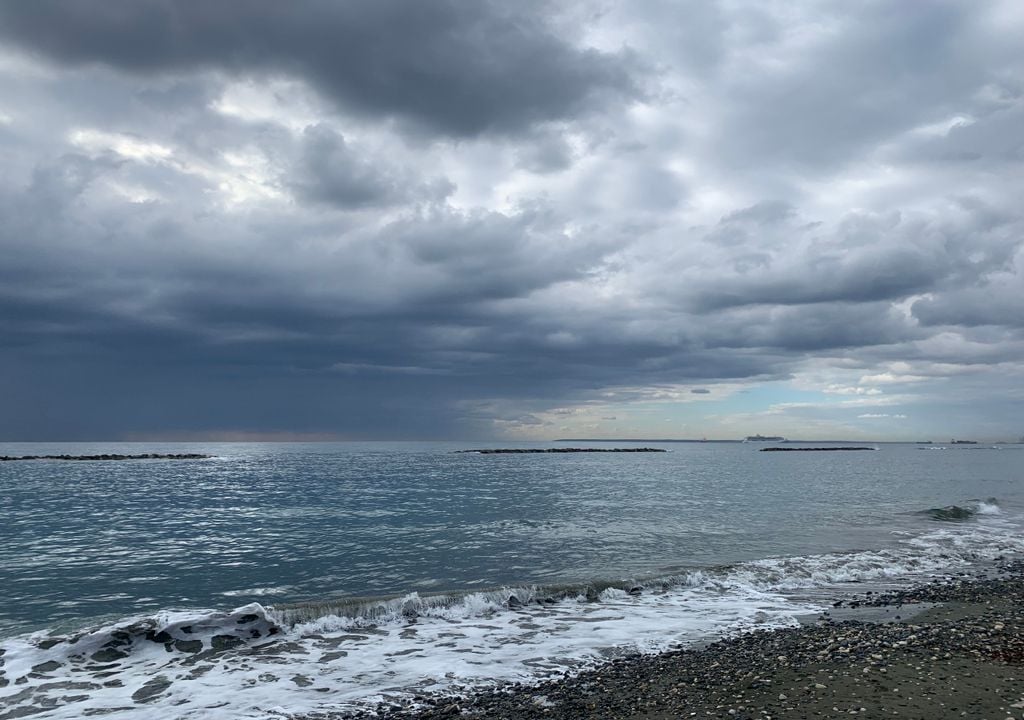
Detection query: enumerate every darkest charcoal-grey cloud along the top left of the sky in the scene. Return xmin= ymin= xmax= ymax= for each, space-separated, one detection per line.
xmin=0 ymin=0 xmax=638 ymax=135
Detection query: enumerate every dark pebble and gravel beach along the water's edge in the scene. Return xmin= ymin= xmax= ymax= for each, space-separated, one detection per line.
xmin=305 ymin=563 xmax=1024 ymax=720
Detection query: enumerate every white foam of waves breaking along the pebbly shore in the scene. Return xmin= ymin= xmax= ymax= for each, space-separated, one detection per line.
xmin=6 ymin=505 xmax=1024 ymax=720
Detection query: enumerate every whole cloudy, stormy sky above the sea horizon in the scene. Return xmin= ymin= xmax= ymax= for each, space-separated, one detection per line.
xmin=0 ymin=0 xmax=1024 ymax=441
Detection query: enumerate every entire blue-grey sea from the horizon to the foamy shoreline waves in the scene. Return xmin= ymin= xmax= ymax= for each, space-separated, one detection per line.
xmin=0 ymin=442 xmax=1024 ymax=719
